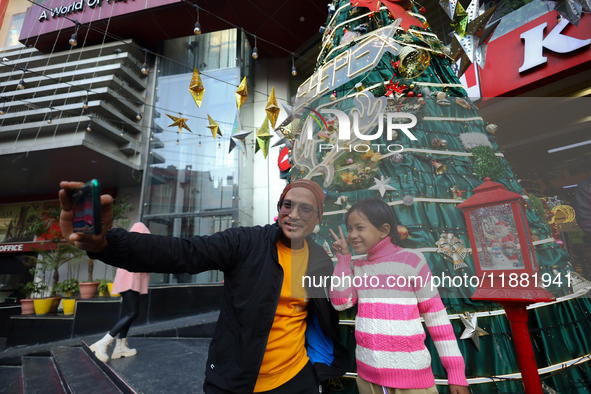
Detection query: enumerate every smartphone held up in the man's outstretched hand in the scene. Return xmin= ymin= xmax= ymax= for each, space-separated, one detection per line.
xmin=72 ymin=179 xmax=102 ymax=235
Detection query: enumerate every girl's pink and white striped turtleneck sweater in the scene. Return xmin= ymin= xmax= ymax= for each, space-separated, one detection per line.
xmin=330 ymin=237 xmax=468 ymax=389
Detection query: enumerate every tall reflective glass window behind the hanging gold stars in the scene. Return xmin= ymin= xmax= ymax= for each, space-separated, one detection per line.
xmin=142 ymin=29 xmax=254 ymax=283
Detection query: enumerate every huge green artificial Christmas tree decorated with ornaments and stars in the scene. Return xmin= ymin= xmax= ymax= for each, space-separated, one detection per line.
xmin=280 ymin=0 xmax=591 ymax=393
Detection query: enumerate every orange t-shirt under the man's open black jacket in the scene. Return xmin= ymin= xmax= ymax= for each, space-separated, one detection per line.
xmin=254 ymin=241 xmax=308 ymax=393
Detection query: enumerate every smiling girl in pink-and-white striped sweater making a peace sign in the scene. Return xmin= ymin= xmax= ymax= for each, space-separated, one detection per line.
xmin=330 ymin=199 xmax=469 ymax=394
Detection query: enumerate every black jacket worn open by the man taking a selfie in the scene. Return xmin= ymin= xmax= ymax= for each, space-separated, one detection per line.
xmin=88 ymin=223 xmax=349 ymax=394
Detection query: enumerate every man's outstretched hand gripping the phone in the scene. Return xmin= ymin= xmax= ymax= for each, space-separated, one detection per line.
xmin=59 ymin=181 xmax=113 ymax=253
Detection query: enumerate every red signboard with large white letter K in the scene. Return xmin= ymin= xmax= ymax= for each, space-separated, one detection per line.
xmin=464 ymin=11 xmax=591 ymax=97
